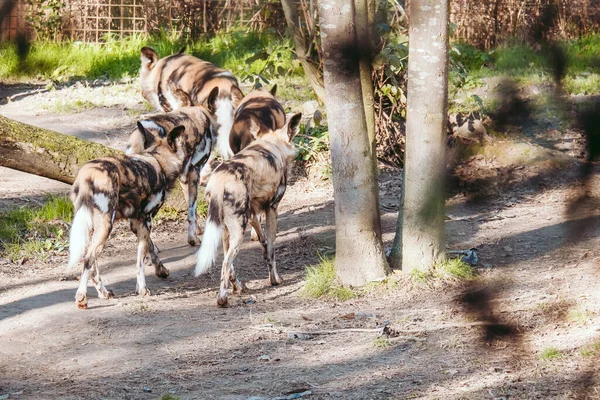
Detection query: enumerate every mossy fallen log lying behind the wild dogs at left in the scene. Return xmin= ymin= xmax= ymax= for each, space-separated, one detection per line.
xmin=0 ymin=115 xmax=187 ymax=210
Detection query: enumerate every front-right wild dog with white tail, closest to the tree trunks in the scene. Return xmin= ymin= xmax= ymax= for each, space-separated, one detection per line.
xmin=194 ymin=114 xmax=302 ymax=307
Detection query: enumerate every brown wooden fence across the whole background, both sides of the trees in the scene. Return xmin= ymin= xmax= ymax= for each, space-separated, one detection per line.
xmin=2 ymin=0 xmax=600 ymax=48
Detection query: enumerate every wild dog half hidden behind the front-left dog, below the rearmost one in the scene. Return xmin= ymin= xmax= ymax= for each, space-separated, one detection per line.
xmin=125 ymin=101 xmax=218 ymax=246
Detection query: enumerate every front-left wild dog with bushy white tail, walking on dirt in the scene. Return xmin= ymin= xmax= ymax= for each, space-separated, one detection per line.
xmin=69 ymin=123 xmax=185 ymax=309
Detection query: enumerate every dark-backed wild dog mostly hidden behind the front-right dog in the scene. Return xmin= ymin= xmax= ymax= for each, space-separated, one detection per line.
xmin=229 ymin=85 xmax=285 ymax=154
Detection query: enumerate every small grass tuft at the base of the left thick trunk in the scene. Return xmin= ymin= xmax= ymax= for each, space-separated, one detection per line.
xmin=302 ymin=258 xmax=356 ymax=301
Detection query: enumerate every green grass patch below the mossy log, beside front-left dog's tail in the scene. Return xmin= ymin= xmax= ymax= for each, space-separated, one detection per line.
xmin=0 ymin=196 xmax=73 ymax=261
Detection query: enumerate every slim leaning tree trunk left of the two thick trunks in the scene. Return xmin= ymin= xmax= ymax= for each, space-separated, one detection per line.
xmin=281 ymin=0 xmax=325 ymax=103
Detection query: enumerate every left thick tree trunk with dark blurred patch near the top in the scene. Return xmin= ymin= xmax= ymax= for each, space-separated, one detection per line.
xmin=319 ymin=0 xmax=387 ymax=286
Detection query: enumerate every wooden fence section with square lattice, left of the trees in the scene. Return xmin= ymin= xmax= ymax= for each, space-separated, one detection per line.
xmin=2 ymin=0 xmax=285 ymax=42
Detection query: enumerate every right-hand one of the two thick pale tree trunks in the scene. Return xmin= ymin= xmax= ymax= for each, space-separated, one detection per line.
xmin=396 ymin=0 xmax=449 ymax=272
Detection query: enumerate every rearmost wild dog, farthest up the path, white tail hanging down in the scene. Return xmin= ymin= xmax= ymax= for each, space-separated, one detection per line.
xmin=140 ymin=47 xmax=244 ymax=164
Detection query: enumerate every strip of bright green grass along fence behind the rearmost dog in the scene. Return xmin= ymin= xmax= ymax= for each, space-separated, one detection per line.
xmin=0 ymin=31 xmax=301 ymax=83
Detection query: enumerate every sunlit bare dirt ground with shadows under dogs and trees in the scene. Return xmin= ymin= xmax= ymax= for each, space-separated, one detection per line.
xmin=0 ymin=81 xmax=600 ymax=400
